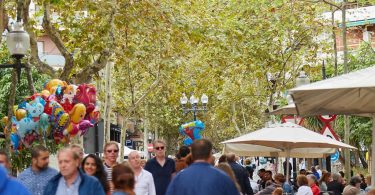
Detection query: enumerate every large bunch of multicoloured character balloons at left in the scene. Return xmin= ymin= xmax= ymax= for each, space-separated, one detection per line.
xmin=2 ymin=79 xmax=100 ymax=150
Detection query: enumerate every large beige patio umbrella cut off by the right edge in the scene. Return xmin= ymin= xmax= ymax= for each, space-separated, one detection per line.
xmin=289 ymin=66 xmax=375 ymax=186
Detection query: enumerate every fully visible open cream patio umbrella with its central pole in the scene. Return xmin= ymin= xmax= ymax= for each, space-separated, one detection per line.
xmin=222 ymin=123 xmax=356 ymax=177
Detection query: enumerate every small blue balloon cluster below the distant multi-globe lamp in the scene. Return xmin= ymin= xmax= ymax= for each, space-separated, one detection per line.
xmin=178 ymin=120 xmax=204 ymax=146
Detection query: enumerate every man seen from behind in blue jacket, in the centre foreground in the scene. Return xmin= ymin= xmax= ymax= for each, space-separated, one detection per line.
xmin=167 ymin=139 xmax=239 ymax=195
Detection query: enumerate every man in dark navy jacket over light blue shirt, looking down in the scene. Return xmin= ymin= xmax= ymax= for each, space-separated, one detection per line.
xmin=44 ymin=147 xmax=105 ymax=195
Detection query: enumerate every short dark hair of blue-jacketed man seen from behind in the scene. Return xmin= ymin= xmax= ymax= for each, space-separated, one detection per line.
xmin=191 ymin=139 xmax=212 ymax=161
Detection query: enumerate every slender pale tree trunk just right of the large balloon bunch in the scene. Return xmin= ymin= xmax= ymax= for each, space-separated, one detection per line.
xmin=103 ymin=62 xmax=113 ymax=144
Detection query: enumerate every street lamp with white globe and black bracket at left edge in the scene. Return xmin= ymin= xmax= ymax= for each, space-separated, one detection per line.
xmin=0 ymin=21 xmax=30 ymax=81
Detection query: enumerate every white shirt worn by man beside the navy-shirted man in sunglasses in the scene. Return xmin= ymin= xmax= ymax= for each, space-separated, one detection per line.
xmin=134 ymin=169 xmax=156 ymax=195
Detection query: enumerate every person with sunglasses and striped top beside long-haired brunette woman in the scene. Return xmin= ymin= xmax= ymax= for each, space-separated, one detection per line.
xmin=103 ymin=141 xmax=119 ymax=192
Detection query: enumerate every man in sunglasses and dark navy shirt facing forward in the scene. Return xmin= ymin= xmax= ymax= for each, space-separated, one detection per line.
xmin=145 ymin=140 xmax=176 ymax=195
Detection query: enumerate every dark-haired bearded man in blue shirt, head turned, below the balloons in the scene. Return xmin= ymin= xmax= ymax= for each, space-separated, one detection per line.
xmin=18 ymin=145 xmax=58 ymax=195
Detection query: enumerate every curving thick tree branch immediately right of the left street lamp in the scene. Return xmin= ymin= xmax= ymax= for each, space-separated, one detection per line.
xmin=22 ymin=0 xmax=56 ymax=77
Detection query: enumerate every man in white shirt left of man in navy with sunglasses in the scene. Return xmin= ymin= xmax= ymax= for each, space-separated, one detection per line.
xmin=128 ymin=151 xmax=156 ymax=195
